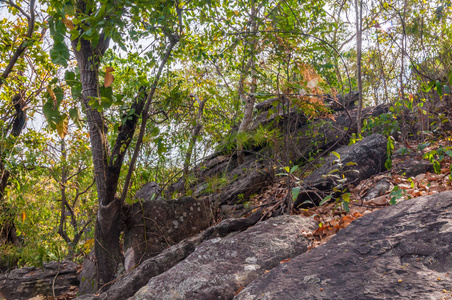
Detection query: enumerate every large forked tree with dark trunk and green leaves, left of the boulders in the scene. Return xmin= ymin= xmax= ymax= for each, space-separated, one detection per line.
xmin=46 ymin=0 xmax=182 ymax=288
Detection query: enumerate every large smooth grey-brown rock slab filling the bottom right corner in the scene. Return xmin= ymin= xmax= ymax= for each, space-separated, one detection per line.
xmin=234 ymin=192 xmax=452 ymax=300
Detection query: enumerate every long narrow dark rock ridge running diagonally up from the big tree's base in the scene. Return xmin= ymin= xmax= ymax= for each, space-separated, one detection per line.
xmin=78 ymin=210 xmax=262 ymax=300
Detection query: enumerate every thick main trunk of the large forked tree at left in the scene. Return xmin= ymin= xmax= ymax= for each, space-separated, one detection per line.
xmin=72 ymin=35 xmax=123 ymax=288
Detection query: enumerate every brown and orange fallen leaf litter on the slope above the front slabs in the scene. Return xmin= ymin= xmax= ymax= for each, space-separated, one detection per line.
xmin=250 ymin=139 xmax=452 ymax=250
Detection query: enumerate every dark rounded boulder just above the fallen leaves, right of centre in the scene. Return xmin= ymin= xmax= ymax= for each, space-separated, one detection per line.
xmin=295 ymin=134 xmax=387 ymax=207
